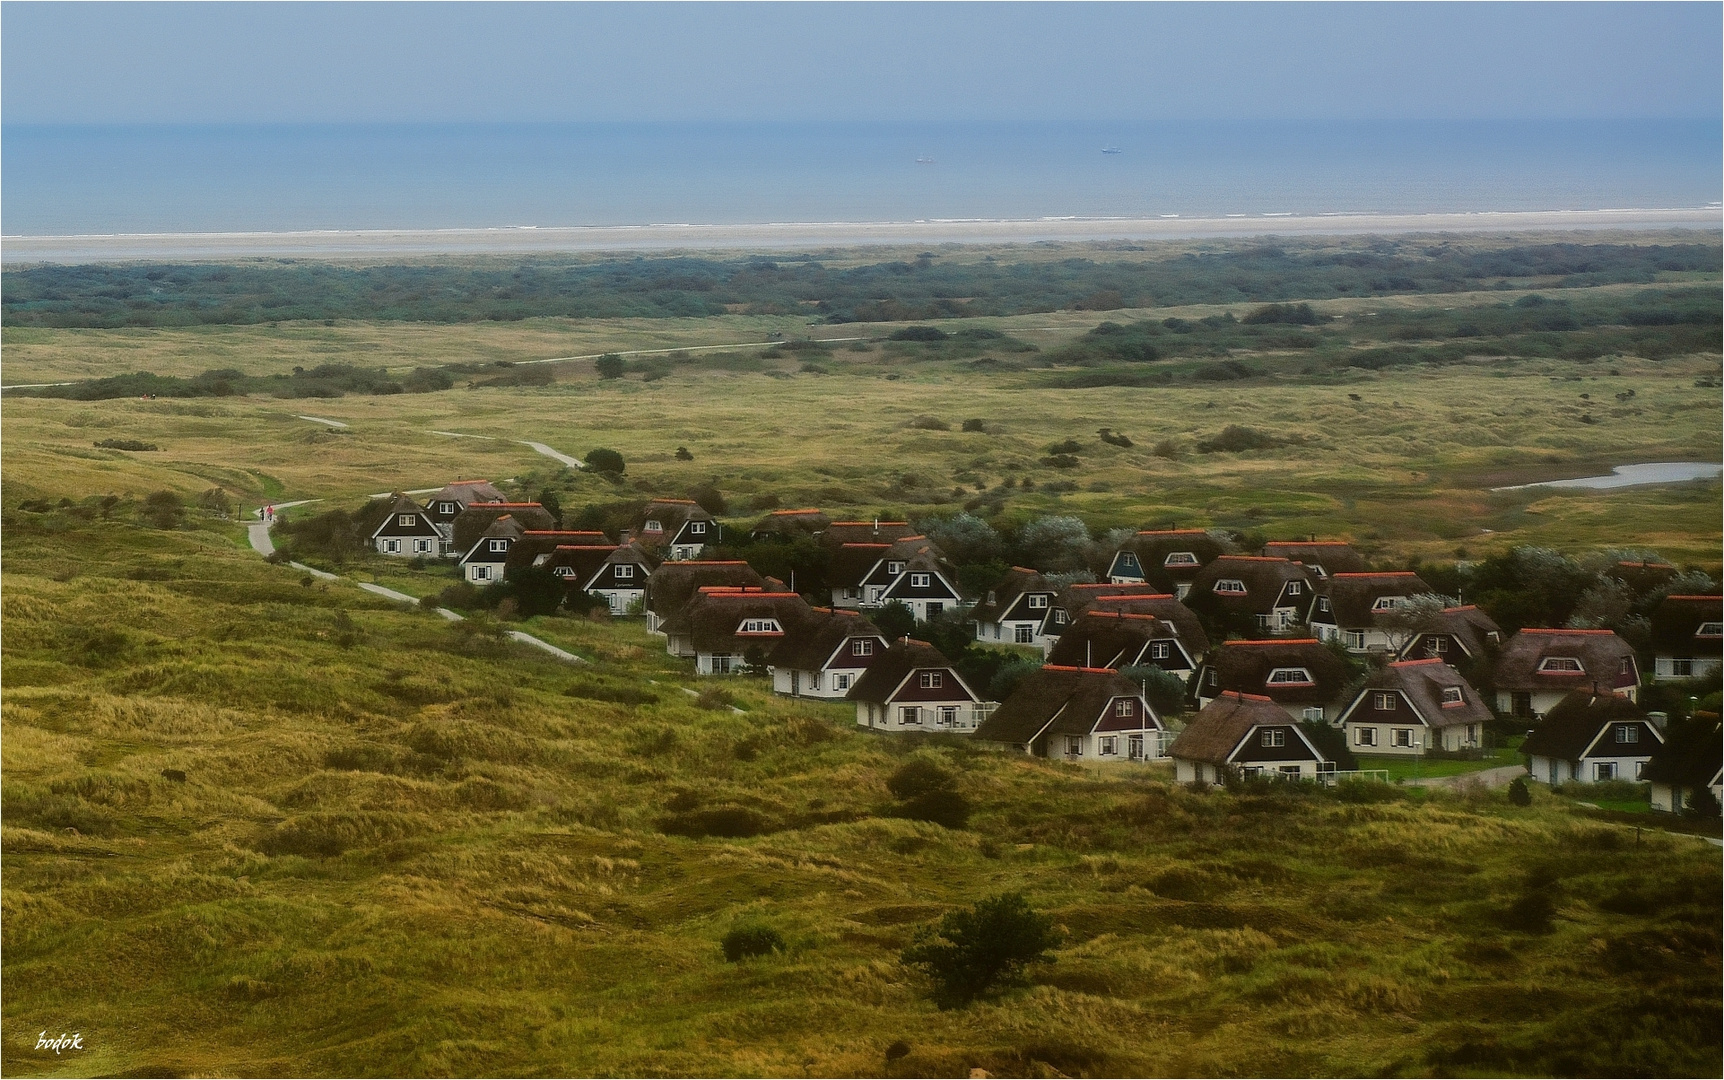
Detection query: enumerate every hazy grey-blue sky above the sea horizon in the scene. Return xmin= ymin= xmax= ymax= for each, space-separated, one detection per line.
xmin=0 ymin=0 xmax=1724 ymax=124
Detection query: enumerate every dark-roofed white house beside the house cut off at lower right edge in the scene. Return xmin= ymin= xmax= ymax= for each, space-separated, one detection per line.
xmin=1521 ymin=690 xmax=1664 ymax=785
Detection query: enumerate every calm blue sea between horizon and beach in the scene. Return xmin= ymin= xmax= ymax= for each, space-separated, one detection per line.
xmin=0 ymin=119 xmax=1724 ymax=236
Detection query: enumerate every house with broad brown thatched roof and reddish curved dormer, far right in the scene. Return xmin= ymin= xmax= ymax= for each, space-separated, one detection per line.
xmin=1493 ymin=628 xmax=1640 ymax=719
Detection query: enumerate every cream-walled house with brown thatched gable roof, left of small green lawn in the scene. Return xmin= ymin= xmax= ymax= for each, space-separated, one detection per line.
xmin=1340 ymin=659 xmax=1491 ymax=757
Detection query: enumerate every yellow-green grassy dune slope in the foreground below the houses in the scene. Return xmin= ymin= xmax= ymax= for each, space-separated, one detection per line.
xmin=0 ymin=510 xmax=1721 ymax=1075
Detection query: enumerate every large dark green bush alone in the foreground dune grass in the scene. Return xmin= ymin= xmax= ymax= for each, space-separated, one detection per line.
xmin=898 ymin=892 xmax=1060 ymax=1009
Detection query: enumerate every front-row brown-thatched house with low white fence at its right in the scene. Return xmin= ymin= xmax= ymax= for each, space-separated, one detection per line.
xmin=1167 ymin=690 xmax=1336 ymax=783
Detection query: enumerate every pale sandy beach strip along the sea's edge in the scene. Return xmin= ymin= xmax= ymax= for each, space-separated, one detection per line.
xmin=0 ymin=207 xmax=1724 ymax=264
